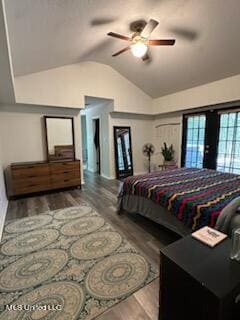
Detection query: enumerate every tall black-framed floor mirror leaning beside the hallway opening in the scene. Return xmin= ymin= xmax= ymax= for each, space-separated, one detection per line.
xmin=113 ymin=127 xmax=133 ymax=179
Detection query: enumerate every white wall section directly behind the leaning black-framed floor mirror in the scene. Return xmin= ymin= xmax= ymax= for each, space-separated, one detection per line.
xmin=110 ymin=114 xmax=153 ymax=178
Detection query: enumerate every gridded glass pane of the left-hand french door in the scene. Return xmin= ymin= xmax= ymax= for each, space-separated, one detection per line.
xmin=185 ymin=114 xmax=206 ymax=168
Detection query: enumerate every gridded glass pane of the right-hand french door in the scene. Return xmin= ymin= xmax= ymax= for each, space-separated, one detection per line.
xmin=217 ymin=112 xmax=240 ymax=174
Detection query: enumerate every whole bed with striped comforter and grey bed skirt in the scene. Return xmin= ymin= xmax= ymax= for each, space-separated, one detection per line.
xmin=118 ymin=168 xmax=240 ymax=235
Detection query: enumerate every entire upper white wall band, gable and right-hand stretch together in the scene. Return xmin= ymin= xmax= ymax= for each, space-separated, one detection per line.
xmin=15 ymin=62 xmax=240 ymax=115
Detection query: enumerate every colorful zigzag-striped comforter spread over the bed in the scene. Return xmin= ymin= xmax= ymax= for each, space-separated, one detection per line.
xmin=122 ymin=168 xmax=240 ymax=230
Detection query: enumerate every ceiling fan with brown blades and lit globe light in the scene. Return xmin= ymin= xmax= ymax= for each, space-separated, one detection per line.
xmin=107 ymin=19 xmax=175 ymax=61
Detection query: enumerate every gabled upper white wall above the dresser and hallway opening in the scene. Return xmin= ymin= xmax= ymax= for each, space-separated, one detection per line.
xmin=15 ymin=62 xmax=152 ymax=113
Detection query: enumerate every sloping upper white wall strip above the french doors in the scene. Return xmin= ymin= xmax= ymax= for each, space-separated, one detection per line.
xmin=153 ymin=75 xmax=240 ymax=114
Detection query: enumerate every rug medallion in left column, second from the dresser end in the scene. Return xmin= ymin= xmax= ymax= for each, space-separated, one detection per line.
xmin=1 ymin=229 xmax=59 ymax=256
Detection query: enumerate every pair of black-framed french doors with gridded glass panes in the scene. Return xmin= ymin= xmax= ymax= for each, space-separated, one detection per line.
xmin=182 ymin=110 xmax=240 ymax=174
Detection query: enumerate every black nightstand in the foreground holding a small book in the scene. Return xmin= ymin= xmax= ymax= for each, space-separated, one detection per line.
xmin=159 ymin=235 xmax=240 ymax=320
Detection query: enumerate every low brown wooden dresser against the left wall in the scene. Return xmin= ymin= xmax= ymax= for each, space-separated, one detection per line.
xmin=6 ymin=160 xmax=81 ymax=198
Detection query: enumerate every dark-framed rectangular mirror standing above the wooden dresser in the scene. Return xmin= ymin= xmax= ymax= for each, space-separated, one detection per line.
xmin=44 ymin=116 xmax=75 ymax=161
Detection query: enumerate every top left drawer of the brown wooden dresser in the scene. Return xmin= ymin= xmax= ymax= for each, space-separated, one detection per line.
xmin=11 ymin=164 xmax=50 ymax=180
